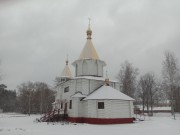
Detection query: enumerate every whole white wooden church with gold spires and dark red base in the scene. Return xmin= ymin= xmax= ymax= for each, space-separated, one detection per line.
xmin=53 ymin=24 xmax=134 ymax=124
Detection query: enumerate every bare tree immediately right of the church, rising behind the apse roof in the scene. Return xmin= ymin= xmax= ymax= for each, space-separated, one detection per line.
xmin=117 ymin=61 xmax=138 ymax=97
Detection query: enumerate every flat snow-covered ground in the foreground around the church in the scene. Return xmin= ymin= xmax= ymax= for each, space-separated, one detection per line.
xmin=0 ymin=113 xmax=180 ymax=135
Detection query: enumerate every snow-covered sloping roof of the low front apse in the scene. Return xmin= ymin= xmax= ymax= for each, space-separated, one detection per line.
xmin=84 ymin=85 xmax=134 ymax=100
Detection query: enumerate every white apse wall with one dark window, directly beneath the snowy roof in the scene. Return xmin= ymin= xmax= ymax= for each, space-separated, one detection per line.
xmin=85 ymin=100 xmax=133 ymax=118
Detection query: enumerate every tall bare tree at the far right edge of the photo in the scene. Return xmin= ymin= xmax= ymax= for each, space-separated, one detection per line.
xmin=162 ymin=52 xmax=180 ymax=116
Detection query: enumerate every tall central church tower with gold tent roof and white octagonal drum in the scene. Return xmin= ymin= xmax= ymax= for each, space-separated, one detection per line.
xmin=72 ymin=21 xmax=106 ymax=77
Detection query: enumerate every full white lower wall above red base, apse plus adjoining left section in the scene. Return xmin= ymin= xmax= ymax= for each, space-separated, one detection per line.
xmin=64 ymin=98 xmax=134 ymax=118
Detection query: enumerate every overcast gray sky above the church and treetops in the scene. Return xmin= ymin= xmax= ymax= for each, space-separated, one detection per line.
xmin=0 ymin=0 xmax=180 ymax=89
